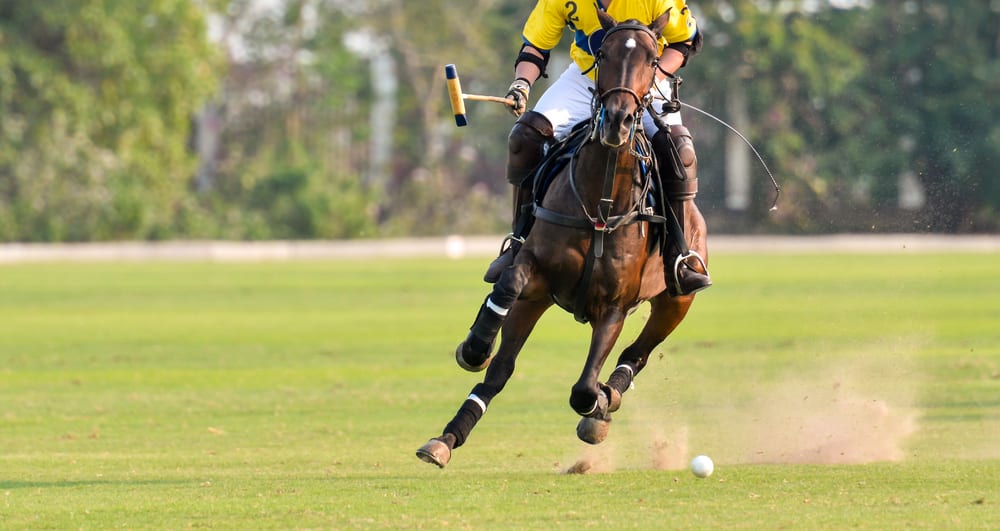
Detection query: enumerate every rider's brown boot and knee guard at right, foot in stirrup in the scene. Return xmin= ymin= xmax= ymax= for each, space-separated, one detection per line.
xmin=652 ymin=125 xmax=712 ymax=296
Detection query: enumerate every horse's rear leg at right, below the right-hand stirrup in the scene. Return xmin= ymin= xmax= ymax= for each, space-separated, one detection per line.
xmin=607 ymin=293 xmax=695 ymax=404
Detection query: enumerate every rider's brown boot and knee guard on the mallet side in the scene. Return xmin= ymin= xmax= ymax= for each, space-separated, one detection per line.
xmin=483 ymin=111 xmax=554 ymax=284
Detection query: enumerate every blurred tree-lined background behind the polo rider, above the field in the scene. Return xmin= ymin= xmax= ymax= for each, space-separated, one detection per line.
xmin=0 ymin=0 xmax=1000 ymax=242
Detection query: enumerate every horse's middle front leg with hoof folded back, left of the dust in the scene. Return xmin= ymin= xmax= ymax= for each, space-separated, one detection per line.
xmin=569 ymin=311 xmax=625 ymax=444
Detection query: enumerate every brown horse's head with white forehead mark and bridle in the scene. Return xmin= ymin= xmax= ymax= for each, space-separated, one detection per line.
xmin=594 ymin=11 xmax=670 ymax=149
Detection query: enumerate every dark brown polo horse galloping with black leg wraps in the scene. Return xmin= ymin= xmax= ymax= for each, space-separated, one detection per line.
xmin=417 ymin=13 xmax=707 ymax=467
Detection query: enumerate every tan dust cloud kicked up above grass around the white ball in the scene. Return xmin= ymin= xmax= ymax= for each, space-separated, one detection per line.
xmin=561 ymin=357 xmax=919 ymax=474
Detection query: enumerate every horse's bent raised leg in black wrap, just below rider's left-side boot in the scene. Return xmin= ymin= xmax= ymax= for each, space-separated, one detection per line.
xmin=455 ymin=264 xmax=530 ymax=372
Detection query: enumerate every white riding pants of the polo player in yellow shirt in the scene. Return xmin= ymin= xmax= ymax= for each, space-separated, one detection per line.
xmin=532 ymin=63 xmax=682 ymax=140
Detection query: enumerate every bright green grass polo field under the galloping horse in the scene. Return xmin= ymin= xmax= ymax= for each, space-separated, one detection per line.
xmin=0 ymin=253 xmax=1000 ymax=529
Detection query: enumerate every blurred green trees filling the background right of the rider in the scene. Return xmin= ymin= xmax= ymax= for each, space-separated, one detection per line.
xmin=685 ymin=0 xmax=1000 ymax=232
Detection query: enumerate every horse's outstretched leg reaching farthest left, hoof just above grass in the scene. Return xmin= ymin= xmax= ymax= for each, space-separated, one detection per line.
xmin=417 ymin=300 xmax=552 ymax=468
